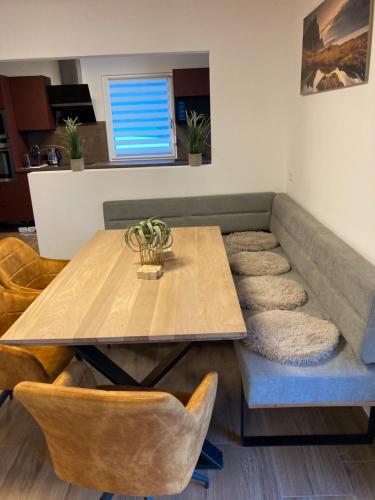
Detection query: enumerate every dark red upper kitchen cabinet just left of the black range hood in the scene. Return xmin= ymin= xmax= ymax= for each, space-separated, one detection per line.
xmin=9 ymin=76 xmax=56 ymax=132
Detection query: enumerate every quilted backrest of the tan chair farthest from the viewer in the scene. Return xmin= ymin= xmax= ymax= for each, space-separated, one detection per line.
xmin=0 ymin=237 xmax=40 ymax=288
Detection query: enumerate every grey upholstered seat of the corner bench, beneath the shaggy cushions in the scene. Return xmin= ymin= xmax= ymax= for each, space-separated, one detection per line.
xmin=235 ymin=247 xmax=375 ymax=407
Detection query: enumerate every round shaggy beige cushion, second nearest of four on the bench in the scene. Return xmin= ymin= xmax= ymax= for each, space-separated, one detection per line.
xmin=236 ymin=276 xmax=307 ymax=311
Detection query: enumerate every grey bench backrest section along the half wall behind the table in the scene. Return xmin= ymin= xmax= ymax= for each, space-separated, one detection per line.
xmin=103 ymin=193 xmax=275 ymax=234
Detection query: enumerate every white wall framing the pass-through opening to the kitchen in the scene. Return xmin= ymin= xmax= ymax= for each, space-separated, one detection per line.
xmin=0 ymin=0 xmax=291 ymax=257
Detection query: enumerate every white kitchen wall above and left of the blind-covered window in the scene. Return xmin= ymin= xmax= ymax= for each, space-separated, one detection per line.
xmin=81 ymin=53 xmax=209 ymax=121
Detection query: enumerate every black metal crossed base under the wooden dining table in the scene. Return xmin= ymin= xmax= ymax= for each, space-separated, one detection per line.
xmin=74 ymin=342 xmax=223 ymax=470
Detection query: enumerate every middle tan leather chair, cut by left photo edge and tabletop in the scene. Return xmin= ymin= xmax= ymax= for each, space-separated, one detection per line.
xmin=0 ymin=286 xmax=73 ymax=406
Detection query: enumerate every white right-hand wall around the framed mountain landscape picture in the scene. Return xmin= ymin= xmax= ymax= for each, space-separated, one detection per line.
xmin=287 ymin=0 xmax=375 ymax=263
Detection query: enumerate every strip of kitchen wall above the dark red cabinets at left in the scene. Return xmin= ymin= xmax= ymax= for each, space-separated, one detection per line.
xmin=0 ymin=60 xmax=61 ymax=85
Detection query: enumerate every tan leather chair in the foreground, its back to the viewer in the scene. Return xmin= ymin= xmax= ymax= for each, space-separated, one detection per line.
xmin=14 ymin=361 xmax=217 ymax=499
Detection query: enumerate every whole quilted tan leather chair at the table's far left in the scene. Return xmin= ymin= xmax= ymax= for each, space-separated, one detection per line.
xmin=0 ymin=237 xmax=69 ymax=292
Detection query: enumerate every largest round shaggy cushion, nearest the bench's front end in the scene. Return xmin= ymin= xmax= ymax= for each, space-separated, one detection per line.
xmin=243 ymin=311 xmax=339 ymax=365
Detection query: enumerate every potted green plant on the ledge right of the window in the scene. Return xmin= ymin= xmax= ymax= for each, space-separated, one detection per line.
xmin=186 ymin=110 xmax=211 ymax=167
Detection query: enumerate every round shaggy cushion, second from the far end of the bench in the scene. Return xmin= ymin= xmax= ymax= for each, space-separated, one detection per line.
xmin=229 ymin=252 xmax=290 ymax=276
